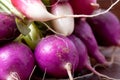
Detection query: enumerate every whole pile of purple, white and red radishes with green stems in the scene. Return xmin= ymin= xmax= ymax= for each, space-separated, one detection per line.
xmin=0 ymin=0 xmax=120 ymax=80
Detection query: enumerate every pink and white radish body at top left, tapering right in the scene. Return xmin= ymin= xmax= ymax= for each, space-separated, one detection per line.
xmin=11 ymin=0 xmax=56 ymax=21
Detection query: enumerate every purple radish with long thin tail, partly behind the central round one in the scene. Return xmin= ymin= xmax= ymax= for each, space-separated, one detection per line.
xmin=68 ymin=35 xmax=117 ymax=79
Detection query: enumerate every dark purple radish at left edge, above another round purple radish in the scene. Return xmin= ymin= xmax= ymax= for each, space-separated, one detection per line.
xmin=0 ymin=12 xmax=20 ymax=43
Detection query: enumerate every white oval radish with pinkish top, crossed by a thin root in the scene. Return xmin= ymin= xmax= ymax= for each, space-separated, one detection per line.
xmin=51 ymin=2 xmax=74 ymax=36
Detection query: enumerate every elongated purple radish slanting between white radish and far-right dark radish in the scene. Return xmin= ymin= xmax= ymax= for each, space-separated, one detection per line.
xmin=74 ymin=19 xmax=106 ymax=64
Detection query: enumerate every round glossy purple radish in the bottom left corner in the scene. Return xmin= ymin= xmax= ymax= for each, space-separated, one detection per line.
xmin=0 ymin=42 xmax=35 ymax=80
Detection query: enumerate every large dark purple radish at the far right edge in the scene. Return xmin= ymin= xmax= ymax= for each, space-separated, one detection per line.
xmin=88 ymin=12 xmax=120 ymax=46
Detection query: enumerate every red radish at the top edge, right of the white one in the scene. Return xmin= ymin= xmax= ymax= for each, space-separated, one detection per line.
xmin=69 ymin=0 xmax=99 ymax=14
